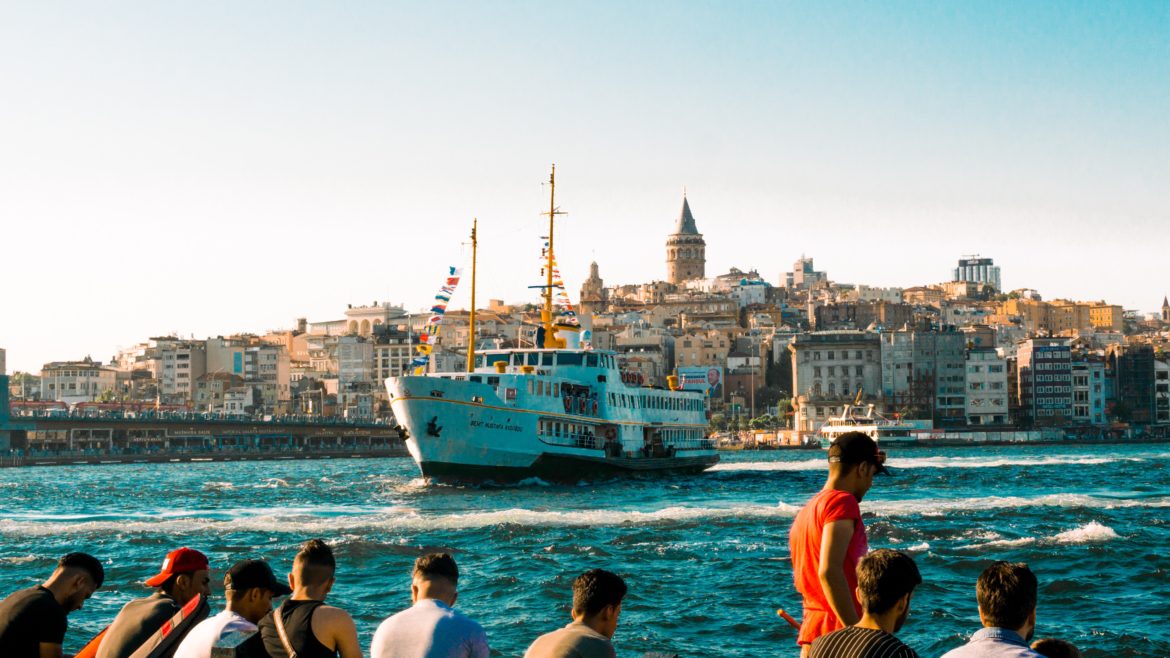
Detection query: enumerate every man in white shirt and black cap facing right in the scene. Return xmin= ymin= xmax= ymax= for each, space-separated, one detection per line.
xmin=174 ymin=560 xmax=293 ymax=658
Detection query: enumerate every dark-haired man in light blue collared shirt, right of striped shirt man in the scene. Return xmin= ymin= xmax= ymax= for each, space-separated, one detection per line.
xmin=943 ymin=562 xmax=1042 ymax=658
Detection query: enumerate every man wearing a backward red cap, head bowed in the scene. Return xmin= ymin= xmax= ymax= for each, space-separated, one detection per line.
xmin=97 ymin=548 xmax=212 ymax=658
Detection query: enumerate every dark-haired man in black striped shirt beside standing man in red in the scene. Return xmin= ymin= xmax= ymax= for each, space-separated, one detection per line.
xmin=808 ymin=548 xmax=922 ymax=658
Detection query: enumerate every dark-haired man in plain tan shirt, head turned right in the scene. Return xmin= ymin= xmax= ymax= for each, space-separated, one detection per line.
xmin=524 ymin=569 xmax=626 ymax=658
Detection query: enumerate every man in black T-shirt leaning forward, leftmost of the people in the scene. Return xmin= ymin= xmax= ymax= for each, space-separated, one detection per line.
xmin=0 ymin=553 xmax=105 ymax=658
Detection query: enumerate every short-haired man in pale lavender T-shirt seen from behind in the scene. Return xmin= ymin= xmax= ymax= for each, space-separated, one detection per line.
xmin=370 ymin=553 xmax=491 ymax=658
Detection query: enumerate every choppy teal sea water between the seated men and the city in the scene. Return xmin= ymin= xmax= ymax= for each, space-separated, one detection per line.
xmin=0 ymin=445 xmax=1170 ymax=657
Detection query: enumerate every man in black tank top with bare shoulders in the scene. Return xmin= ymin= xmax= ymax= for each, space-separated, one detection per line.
xmin=259 ymin=540 xmax=362 ymax=658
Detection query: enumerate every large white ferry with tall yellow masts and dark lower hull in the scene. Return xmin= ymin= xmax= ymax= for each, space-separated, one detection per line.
xmin=386 ymin=167 xmax=718 ymax=482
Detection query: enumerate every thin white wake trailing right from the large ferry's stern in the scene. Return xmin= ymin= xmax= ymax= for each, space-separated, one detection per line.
xmin=708 ymin=453 xmax=1151 ymax=472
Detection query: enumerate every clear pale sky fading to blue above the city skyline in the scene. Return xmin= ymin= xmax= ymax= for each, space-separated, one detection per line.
xmin=0 ymin=1 xmax=1170 ymax=370
